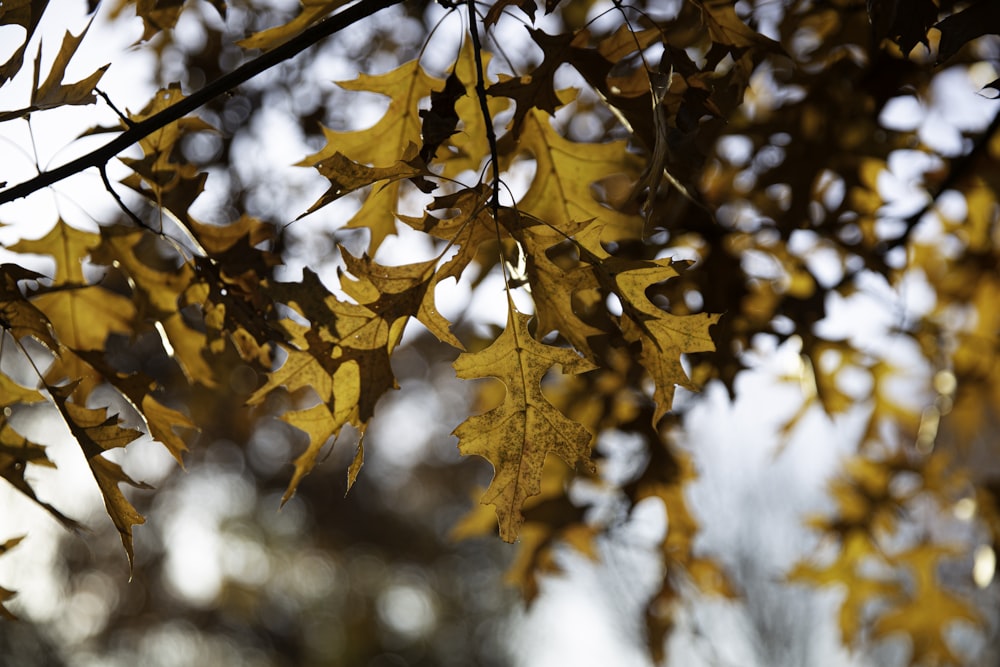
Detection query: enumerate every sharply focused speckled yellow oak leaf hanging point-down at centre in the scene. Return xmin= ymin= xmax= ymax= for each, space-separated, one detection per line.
xmin=453 ymin=304 xmax=593 ymax=542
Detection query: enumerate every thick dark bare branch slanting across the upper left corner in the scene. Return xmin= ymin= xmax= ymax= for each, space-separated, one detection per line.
xmin=0 ymin=0 xmax=403 ymax=205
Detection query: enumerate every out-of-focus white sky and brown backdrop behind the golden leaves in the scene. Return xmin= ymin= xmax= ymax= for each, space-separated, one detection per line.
xmin=0 ymin=0 xmax=1000 ymax=667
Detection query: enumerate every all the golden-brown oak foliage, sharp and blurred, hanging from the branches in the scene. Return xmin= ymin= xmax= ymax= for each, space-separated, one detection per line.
xmin=0 ymin=0 xmax=1000 ymax=663
